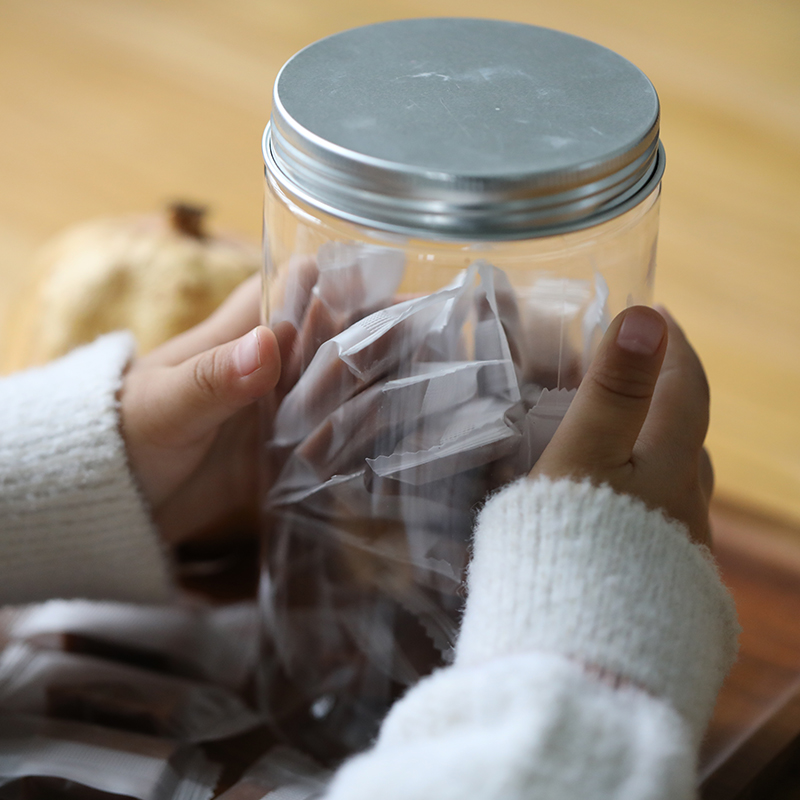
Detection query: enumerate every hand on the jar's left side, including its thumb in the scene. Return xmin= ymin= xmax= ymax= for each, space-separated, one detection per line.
xmin=120 ymin=277 xmax=281 ymax=545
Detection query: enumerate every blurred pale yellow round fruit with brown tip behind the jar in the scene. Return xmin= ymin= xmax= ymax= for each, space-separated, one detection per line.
xmin=28 ymin=203 xmax=261 ymax=363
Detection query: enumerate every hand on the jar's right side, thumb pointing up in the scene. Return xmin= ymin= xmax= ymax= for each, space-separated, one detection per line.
xmin=531 ymin=306 xmax=714 ymax=544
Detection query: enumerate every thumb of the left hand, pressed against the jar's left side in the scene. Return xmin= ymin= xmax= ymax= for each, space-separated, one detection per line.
xmin=151 ymin=325 xmax=281 ymax=446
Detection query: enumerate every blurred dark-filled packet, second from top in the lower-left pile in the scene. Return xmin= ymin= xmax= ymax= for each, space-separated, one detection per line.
xmin=0 ymin=642 xmax=262 ymax=742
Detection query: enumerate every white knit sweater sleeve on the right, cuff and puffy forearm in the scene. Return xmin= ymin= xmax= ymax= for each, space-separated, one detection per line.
xmin=326 ymin=479 xmax=738 ymax=800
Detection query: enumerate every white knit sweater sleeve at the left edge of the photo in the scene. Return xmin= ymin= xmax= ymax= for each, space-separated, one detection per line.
xmin=0 ymin=333 xmax=172 ymax=603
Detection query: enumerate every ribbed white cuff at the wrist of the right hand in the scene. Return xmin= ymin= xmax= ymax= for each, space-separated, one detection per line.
xmin=456 ymin=478 xmax=739 ymax=737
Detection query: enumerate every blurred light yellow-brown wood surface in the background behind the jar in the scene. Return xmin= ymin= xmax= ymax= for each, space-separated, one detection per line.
xmin=0 ymin=0 xmax=800 ymax=521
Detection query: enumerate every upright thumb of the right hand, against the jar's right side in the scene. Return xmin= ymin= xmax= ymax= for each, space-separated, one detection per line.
xmin=536 ymin=306 xmax=667 ymax=476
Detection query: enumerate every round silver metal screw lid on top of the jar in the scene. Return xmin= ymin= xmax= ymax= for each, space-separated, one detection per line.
xmin=263 ymin=18 xmax=664 ymax=239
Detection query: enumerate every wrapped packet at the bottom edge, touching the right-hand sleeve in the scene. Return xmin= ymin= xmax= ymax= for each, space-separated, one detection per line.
xmin=217 ymin=746 xmax=332 ymax=800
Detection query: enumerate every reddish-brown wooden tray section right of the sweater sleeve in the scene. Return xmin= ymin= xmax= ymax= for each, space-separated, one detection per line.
xmin=700 ymin=502 xmax=800 ymax=800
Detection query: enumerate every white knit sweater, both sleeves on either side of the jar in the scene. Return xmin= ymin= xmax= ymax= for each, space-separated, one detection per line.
xmin=0 ymin=334 xmax=738 ymax=800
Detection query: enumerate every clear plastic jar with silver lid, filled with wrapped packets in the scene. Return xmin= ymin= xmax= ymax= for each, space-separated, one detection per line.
xmin=261 ymin=19 xmax=664 ymax=761
